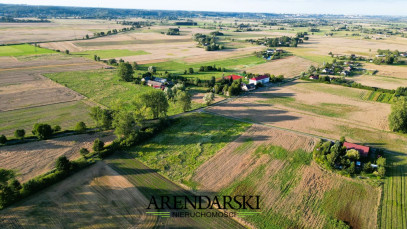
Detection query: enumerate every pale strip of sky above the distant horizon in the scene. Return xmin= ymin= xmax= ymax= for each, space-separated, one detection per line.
xmin=0 ymin=0 xmax=407 ymax=16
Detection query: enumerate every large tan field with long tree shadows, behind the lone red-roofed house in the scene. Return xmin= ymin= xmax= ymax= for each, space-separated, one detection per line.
xmin=207 ymin=81 xmax=407 ymax=152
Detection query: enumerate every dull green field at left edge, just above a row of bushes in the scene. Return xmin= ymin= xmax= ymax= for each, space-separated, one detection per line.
xmin=0 ymin=101 xmax=94 ymax=136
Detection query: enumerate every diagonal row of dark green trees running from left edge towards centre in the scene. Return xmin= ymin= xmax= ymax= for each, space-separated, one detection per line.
xmin=0 ymin=108 xmax=170 ymax=209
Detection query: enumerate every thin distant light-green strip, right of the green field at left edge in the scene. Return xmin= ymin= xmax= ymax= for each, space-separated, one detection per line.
xmin=72 ymin=49 xmax=150 ymax=60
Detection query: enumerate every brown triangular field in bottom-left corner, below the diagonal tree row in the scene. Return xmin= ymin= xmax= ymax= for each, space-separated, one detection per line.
xmin=0 ymin=162 xmax=157 ymax=228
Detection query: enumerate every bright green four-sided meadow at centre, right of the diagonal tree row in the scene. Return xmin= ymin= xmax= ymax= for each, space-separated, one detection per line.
xmin=125 ymin=113 xmax=250 ymax=187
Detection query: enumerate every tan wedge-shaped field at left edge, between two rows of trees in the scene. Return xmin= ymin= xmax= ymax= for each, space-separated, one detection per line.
xmin=0 ymin=132 xmax=115 ymax=182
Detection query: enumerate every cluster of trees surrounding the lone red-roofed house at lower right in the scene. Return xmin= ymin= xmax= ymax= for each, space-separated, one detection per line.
xmin=313 ymin=137 xmax=386 ymax=178
